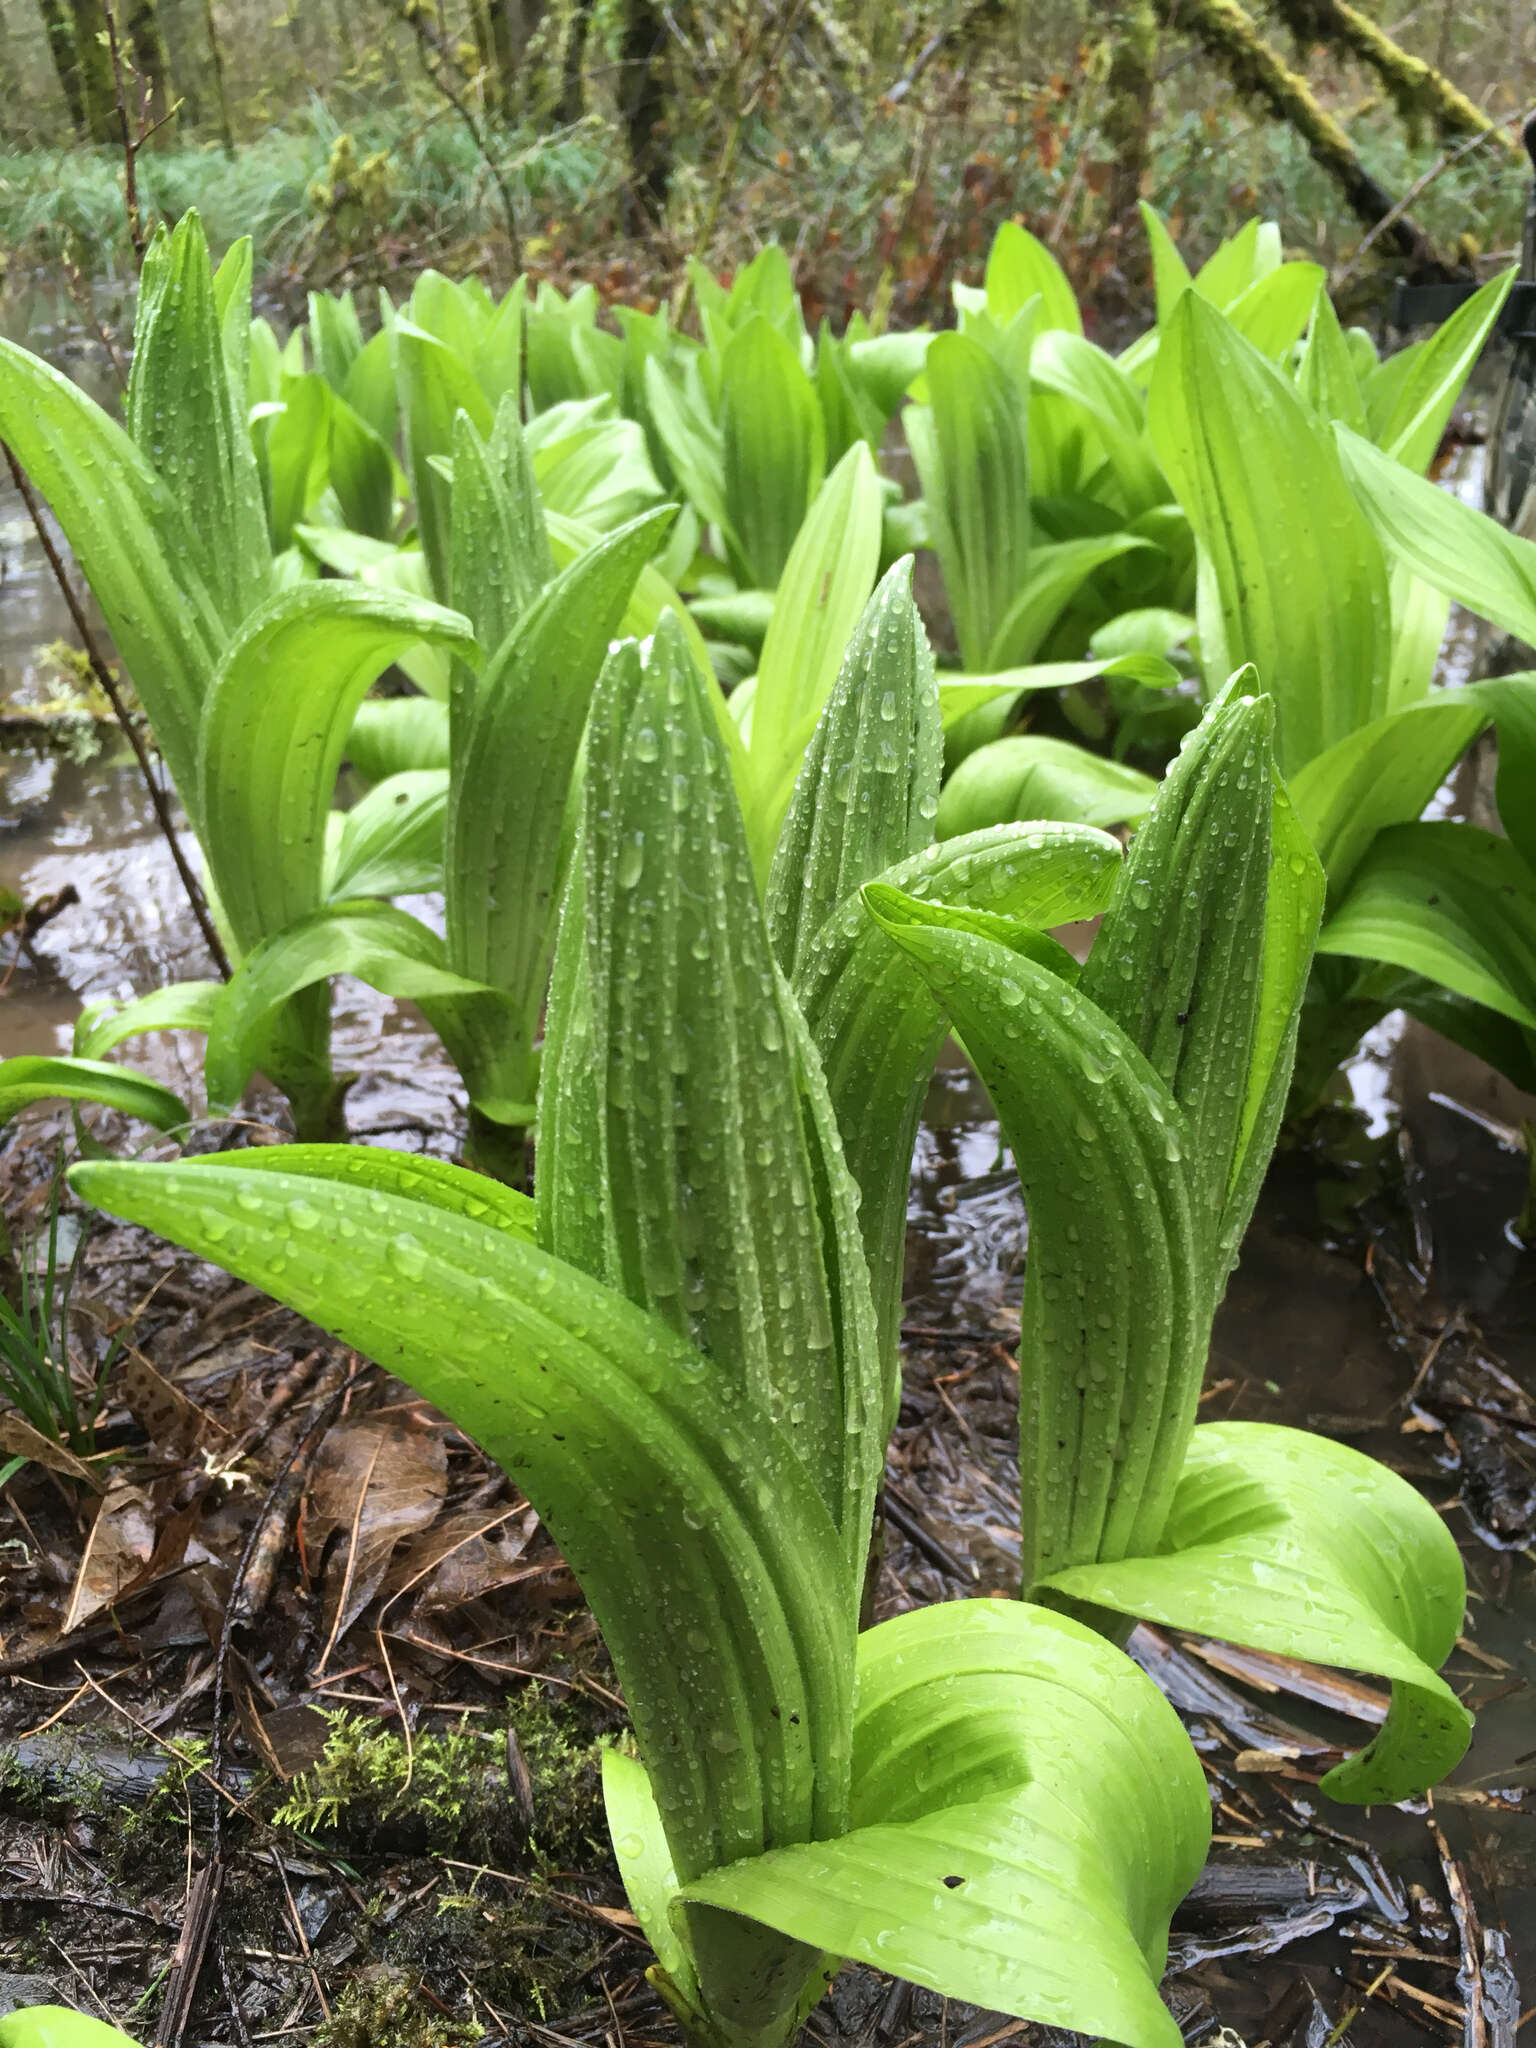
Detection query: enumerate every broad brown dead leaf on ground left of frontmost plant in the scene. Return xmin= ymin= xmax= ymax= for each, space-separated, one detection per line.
xmin=305 ymin=1415 xmax=449 ymax=1677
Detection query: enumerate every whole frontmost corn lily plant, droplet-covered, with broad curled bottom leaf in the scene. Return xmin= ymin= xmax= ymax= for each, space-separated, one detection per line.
xmin=76 ymin=590 xmax=1208 ymax=2048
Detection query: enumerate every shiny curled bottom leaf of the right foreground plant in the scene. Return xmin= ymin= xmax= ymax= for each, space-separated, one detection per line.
xmin=1049 ymin=1421 xmax=1473 ymax=1804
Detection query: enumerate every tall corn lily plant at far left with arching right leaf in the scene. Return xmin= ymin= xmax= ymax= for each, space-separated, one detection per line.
xmin=0 ymin=215 xmax=477 ymax=1135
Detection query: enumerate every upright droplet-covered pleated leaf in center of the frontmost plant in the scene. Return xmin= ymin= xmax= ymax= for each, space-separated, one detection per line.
xmin=541 ymin=618 xmax=881 ymax=1567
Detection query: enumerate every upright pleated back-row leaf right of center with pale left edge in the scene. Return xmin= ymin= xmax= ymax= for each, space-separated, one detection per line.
xmin=907 ymin=334 xmax=1030 ymax=670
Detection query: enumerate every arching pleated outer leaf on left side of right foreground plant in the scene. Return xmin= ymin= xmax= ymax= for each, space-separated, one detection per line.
xmin=864 ymin=885 xmax=1214 ymax=1591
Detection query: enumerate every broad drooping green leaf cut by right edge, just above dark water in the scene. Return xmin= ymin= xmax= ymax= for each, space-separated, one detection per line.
xmin=1317 ymin=823 xmax=1536 ymax=1030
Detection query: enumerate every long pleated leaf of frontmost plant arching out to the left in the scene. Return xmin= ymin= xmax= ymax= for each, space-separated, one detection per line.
xmin=74 ymin=1147 xmax=852 ymax=1876
